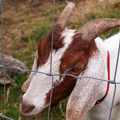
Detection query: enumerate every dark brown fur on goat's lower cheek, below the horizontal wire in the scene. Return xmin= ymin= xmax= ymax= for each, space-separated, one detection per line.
xmin=45 ymin=76 xmax=76 ymax=107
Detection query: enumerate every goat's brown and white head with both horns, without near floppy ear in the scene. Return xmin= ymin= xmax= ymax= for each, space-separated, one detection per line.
xmin=20 ymin=3 xmax=120 ymax=116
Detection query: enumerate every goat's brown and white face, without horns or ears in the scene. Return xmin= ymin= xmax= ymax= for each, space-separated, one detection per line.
xmin=20 ymin=25 xmax=89 ymax=116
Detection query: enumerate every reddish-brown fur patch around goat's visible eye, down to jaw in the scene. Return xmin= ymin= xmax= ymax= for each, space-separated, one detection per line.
xmin=45 ymin=34 xmax=97 ymax=106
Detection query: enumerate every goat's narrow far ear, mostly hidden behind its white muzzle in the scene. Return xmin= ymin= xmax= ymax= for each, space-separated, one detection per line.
xmin=21 ymin=51 xmax=38 ymax=92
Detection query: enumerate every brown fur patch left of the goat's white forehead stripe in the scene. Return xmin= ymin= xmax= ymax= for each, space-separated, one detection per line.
xmin=37 ymin=25 xmax=64 ymax=68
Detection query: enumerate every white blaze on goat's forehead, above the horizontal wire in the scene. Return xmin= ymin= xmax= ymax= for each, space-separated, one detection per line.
xmin=38 ymin=29 xmax=75 ymax=73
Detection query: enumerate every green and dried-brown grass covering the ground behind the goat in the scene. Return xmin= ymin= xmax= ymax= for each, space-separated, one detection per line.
xmin=0 ymin=0 xmax=120 ymax=120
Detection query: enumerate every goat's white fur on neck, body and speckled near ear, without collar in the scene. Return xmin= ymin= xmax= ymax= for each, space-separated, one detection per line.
xmin=66 ymin=33 xmax=120 ymax=120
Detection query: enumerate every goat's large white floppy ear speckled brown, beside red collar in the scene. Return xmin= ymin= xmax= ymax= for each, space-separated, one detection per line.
xmin=66 ymin=52 xmax=105 ymax=120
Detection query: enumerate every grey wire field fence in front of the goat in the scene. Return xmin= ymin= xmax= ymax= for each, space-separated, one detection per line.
xmin=0 ymin=0 xmax=120 ymax=120
